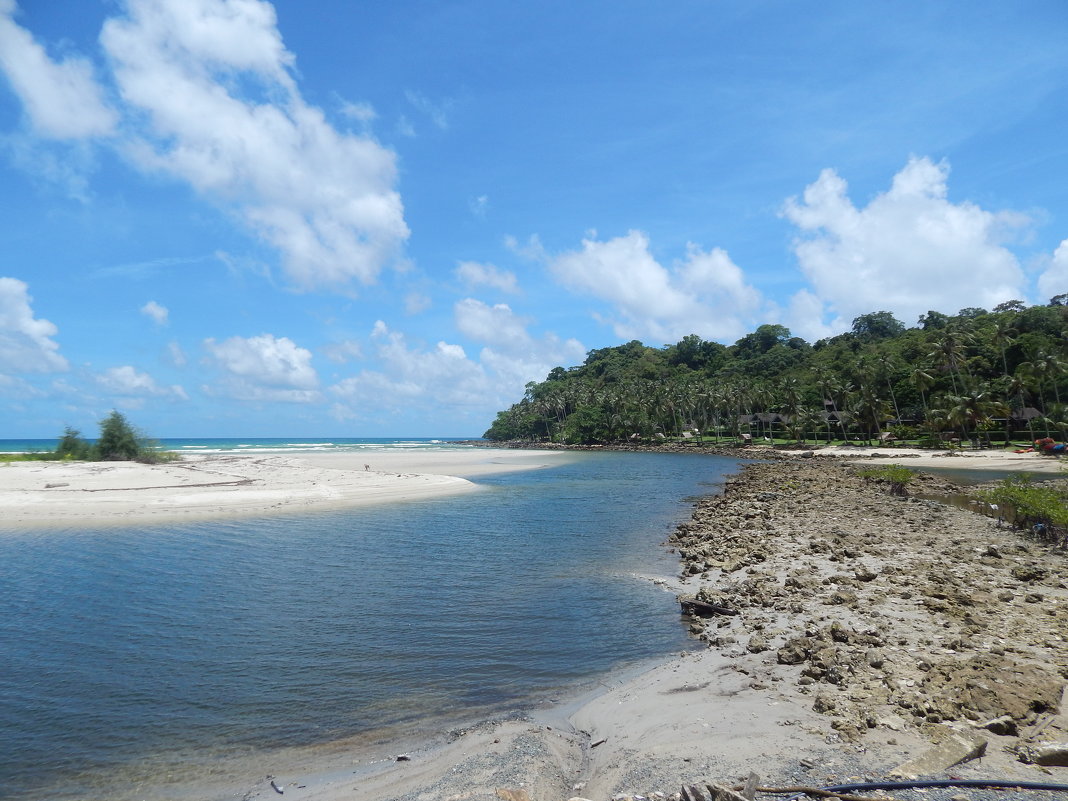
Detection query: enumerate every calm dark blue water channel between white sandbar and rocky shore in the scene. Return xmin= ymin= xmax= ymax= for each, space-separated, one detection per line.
xmin=0 ymin=443 xmax=736 ymax=799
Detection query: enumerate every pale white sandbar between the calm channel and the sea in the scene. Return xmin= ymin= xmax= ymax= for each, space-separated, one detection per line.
xmin=0 ymin=449 xmax=567 ymax=530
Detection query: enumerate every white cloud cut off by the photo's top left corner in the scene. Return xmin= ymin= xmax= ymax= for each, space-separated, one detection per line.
xmin=0 ymin=0 xmax=117 ymax=139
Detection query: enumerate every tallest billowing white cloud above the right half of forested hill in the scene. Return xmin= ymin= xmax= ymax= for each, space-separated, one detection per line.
xmin=783 ymin=158 xmax=1028 ymax=330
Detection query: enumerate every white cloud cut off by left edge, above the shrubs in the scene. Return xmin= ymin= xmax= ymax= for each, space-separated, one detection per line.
xmin=0 ymin=278 xmax=67 ymax=373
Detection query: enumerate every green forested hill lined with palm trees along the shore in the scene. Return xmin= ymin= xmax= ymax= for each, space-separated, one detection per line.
xmin=484 ymin=295 xmax=1068 ymax=443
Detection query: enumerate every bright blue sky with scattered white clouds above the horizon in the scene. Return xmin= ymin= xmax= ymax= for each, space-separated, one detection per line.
xmin=0 ymin=0 xmax=1068 ymax=438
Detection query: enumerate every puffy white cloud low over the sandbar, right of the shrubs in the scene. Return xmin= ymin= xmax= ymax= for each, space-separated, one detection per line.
xmin=204 ymin=334 xmax=320 ymax=403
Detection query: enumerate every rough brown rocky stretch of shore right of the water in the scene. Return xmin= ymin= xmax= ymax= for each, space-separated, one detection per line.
xmin=671 ymin=459 xmax=1068 ymax=770
